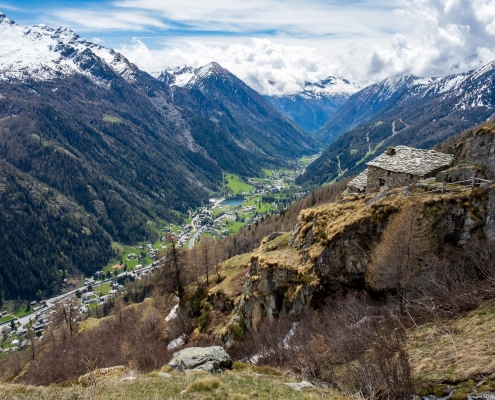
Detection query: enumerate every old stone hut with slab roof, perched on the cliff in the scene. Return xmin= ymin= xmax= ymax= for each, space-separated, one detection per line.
xmin=347 ymin=146 xmax=453 ymax=193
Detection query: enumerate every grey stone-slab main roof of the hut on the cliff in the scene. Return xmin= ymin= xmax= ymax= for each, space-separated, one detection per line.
xmin=367 ymin=146 xmax=454 ymax=176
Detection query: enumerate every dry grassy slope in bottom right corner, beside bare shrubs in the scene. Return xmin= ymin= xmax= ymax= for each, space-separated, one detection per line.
xmin=409 ymin=302 xmax=495 ymax=382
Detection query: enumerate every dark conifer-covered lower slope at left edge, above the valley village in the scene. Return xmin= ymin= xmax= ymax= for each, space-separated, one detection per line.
xmin=0 ymin=161 xmax=113 ymax=304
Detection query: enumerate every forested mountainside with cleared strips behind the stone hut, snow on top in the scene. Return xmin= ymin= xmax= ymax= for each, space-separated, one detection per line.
xmin=297 ymin=62 xmax=495 ymax=188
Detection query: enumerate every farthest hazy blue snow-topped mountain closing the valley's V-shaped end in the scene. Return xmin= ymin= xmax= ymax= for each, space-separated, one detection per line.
xmin=265 ymin=76 xmax=359 ymax=133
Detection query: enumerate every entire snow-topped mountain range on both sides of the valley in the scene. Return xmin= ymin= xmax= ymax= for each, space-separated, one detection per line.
xmin=0 ymin=8 xmax=495 ymax=302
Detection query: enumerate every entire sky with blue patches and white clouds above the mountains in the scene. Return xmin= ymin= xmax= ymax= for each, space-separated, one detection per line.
xmin=0 ymin=0 xmax=495 ymax=95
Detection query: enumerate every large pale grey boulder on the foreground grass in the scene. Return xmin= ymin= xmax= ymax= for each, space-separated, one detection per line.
xmin=168 ymin=346 xmax=232 ymax=373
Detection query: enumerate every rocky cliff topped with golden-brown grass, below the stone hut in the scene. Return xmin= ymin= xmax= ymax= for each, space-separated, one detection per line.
xmin=219 ymin=188 xmax=495 ymax=342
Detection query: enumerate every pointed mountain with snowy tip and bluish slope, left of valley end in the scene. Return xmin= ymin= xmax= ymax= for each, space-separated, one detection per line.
xmin=157 ymin=62 xmax=318 ymax=162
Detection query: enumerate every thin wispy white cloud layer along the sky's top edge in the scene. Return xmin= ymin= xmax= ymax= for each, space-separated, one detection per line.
xmin=114 ymin=0 xmax=393 ymax=36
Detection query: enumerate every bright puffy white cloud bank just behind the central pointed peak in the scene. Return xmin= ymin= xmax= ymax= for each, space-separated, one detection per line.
xmin=120 ymin=39 xmax=340 ymax=95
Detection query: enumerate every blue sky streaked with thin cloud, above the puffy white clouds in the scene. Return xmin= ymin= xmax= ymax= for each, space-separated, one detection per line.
xmin=0 ymin=0 xmax=399 ymax=48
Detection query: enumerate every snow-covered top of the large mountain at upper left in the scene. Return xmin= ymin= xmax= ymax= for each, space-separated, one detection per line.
xmin=0 ymin=13 xmax=138 ymax=83
